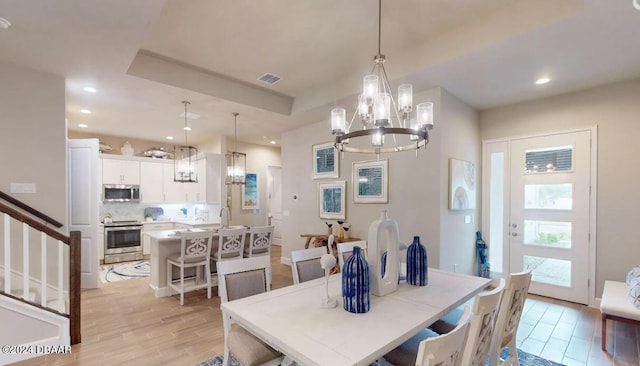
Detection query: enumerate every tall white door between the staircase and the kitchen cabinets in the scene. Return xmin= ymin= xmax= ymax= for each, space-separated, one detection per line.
xmin=67 ymin=139 xmax=100 ymax=288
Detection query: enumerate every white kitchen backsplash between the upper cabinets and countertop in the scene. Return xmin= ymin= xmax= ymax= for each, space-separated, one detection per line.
xmin=98 ymin=202 xmax=220 ymax=222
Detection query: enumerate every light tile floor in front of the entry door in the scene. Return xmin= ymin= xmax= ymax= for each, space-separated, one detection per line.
xmin=517 ymin=295 xmax=640 ymax=366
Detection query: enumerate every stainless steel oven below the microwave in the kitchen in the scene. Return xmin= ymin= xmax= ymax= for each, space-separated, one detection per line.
xmin=104 ymin=221 xmax=142 ymax=263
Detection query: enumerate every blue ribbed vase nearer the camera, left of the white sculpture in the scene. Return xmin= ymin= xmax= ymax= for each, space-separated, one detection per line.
xmin=342 ymin=246 xmax=371 ymax=313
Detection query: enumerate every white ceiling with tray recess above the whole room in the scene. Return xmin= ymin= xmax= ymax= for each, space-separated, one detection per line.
xmin=0 ymin=0 xmax=640 ymax=144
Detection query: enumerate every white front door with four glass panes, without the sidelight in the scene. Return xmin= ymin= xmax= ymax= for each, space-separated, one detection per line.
xmin=509 ymin=131 xmax=591 ymax=304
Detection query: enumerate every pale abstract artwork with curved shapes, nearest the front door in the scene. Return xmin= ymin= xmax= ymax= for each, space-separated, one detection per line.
xmin=449 ymin=158 xmax=476 ymax=210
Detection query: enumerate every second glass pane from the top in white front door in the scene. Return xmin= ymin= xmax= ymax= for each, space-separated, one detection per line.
xmin=524 ymin=183 xmax=573 ymax=210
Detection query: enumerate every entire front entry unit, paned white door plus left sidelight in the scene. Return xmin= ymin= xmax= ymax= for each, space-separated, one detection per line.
xmin=482 ymin=128 xmax=596 ymax=304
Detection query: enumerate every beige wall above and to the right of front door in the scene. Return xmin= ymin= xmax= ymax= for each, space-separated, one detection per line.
xmin=480 ymin=80 xmax=640 ymax=297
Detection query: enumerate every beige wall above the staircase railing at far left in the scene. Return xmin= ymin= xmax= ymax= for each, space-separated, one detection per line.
xmin=0 ymin=64 xmax=68 ymax=229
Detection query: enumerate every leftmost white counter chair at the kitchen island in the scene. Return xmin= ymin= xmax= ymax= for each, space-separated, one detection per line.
xmin=167 ymin=230 xmax=213 ymax=305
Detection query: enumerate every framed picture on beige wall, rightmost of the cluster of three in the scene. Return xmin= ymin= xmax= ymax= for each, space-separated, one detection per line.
xmin=353 ymin=160 xmax=389 ymax=203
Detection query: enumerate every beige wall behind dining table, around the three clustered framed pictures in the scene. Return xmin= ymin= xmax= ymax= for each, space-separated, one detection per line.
xmin=282 ymin=88 xmax=480 ymax=272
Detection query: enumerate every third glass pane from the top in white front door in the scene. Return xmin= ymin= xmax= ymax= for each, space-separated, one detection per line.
xmin=523 ymin=220 xmax=571 ymax=248
